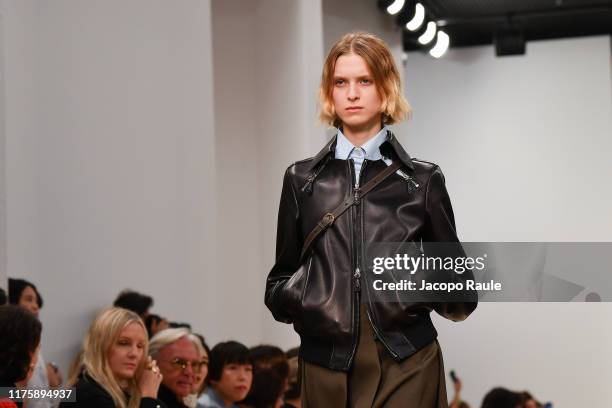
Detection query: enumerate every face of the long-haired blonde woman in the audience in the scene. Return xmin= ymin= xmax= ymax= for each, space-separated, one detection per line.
xmin=108 ymin=322 xmax=147 ymax=383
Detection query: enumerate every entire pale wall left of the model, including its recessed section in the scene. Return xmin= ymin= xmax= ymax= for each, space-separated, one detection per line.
xmin=4 ymin=0 xmax=325 ymax=371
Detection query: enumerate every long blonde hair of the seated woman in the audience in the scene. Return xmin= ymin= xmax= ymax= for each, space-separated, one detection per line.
xmin=81 ymin=307 xmax=148 ymax=408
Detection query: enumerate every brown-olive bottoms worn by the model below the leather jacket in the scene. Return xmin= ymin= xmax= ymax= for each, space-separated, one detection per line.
xmin=300 ymin=305 xmax=448 ymax=408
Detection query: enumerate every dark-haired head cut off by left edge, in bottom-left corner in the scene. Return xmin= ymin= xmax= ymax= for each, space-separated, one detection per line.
xmin=0 ymin=306 xmax=42 ymax=408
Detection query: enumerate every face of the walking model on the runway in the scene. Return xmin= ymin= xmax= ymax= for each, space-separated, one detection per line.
xmin=332 ymin=54 xmax=382 ymax=130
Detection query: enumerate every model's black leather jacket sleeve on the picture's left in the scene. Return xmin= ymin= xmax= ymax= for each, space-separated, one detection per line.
xmin=265 ymin=167 xmax=302 ymax=323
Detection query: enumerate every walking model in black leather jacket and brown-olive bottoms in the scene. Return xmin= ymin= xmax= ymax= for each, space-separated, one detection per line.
xmin=265 ymin=32 xmax=477 ymax=408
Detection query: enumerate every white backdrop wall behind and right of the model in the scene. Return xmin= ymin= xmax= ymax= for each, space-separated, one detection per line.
xmin=323 ymin=0 xmax=612 ymax=407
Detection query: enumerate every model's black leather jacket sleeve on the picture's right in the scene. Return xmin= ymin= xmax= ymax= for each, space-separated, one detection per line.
xmin=423 ymin=166 xmax=478 ymax=321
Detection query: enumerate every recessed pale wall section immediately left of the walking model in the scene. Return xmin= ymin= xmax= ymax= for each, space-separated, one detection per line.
xmin=212 ymin=0 xmax=324 ymax=348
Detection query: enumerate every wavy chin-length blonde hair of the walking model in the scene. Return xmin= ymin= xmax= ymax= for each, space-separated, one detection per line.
xmin=319 ymin=31 xmax=412 ymax=127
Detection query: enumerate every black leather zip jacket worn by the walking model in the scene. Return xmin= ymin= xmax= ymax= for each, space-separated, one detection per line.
xmin=265 ymin=132 xmax=477 ymax=371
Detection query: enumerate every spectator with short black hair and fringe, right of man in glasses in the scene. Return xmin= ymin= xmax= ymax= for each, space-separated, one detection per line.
xmin=198 ymin=341 xmax=253 ymax=408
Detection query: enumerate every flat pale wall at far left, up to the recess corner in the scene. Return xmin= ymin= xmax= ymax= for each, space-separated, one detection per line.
xmin=4 ymin=0 xmax=220 ymax=372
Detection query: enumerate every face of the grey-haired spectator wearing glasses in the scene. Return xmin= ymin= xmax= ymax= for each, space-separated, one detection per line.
xmin=157 ymin=337 xmax=200 ymax=398
